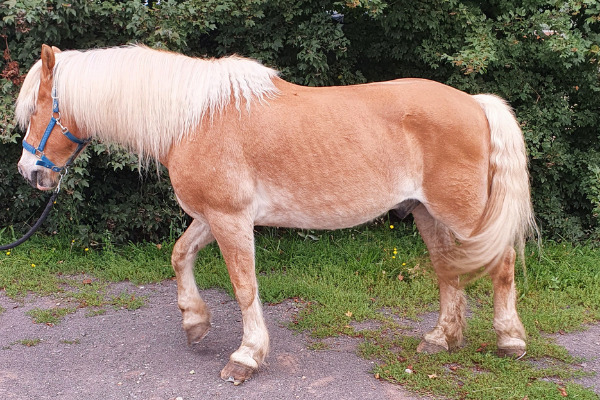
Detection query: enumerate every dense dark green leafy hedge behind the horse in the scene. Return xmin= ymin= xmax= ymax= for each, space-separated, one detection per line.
xmin=0 ymin=0 xmax=600 ymax=242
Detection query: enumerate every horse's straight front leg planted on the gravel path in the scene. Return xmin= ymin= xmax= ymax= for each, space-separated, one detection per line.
xmin=209 ymin=213 xmax=269 ymax=385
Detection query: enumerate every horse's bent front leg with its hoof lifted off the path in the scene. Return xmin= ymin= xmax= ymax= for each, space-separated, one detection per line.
xmin=171 ymin=219 xmax=214 ymax=344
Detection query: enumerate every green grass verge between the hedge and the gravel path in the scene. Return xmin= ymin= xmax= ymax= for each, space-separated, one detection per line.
xmin=0 ymin=221 xmax=600 ymax=399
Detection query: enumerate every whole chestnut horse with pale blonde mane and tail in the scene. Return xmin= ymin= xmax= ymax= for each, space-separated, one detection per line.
xmin=16 ymin=45 xmax=534 ymax=384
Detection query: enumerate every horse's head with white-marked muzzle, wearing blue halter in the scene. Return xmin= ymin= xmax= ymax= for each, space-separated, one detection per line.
xmin=16 ymin=45 xmax=87 ymax=190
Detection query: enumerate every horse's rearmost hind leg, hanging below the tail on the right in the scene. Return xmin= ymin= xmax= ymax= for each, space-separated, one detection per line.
xmin=490 ymin=247 xmax=525 ymax=357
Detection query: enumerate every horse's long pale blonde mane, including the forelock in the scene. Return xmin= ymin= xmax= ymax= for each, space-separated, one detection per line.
xmin=15 ymin=46 xmax=277 ymax=159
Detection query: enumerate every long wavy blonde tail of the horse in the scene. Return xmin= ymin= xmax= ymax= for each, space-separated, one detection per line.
xmin=451 ymin=94 xmax=537 ymax=280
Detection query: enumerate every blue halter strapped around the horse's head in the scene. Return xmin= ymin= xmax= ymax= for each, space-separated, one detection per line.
xmin=23 ymin=86 xmax=90 ymax=172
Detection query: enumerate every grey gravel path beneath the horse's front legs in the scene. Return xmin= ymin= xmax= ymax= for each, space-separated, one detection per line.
xmin=0 ymin=281 xmax=428 ymax=400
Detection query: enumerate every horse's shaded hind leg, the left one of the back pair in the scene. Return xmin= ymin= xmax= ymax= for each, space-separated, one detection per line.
xmin=413 ymin=205 xmax=466 ymax=353
